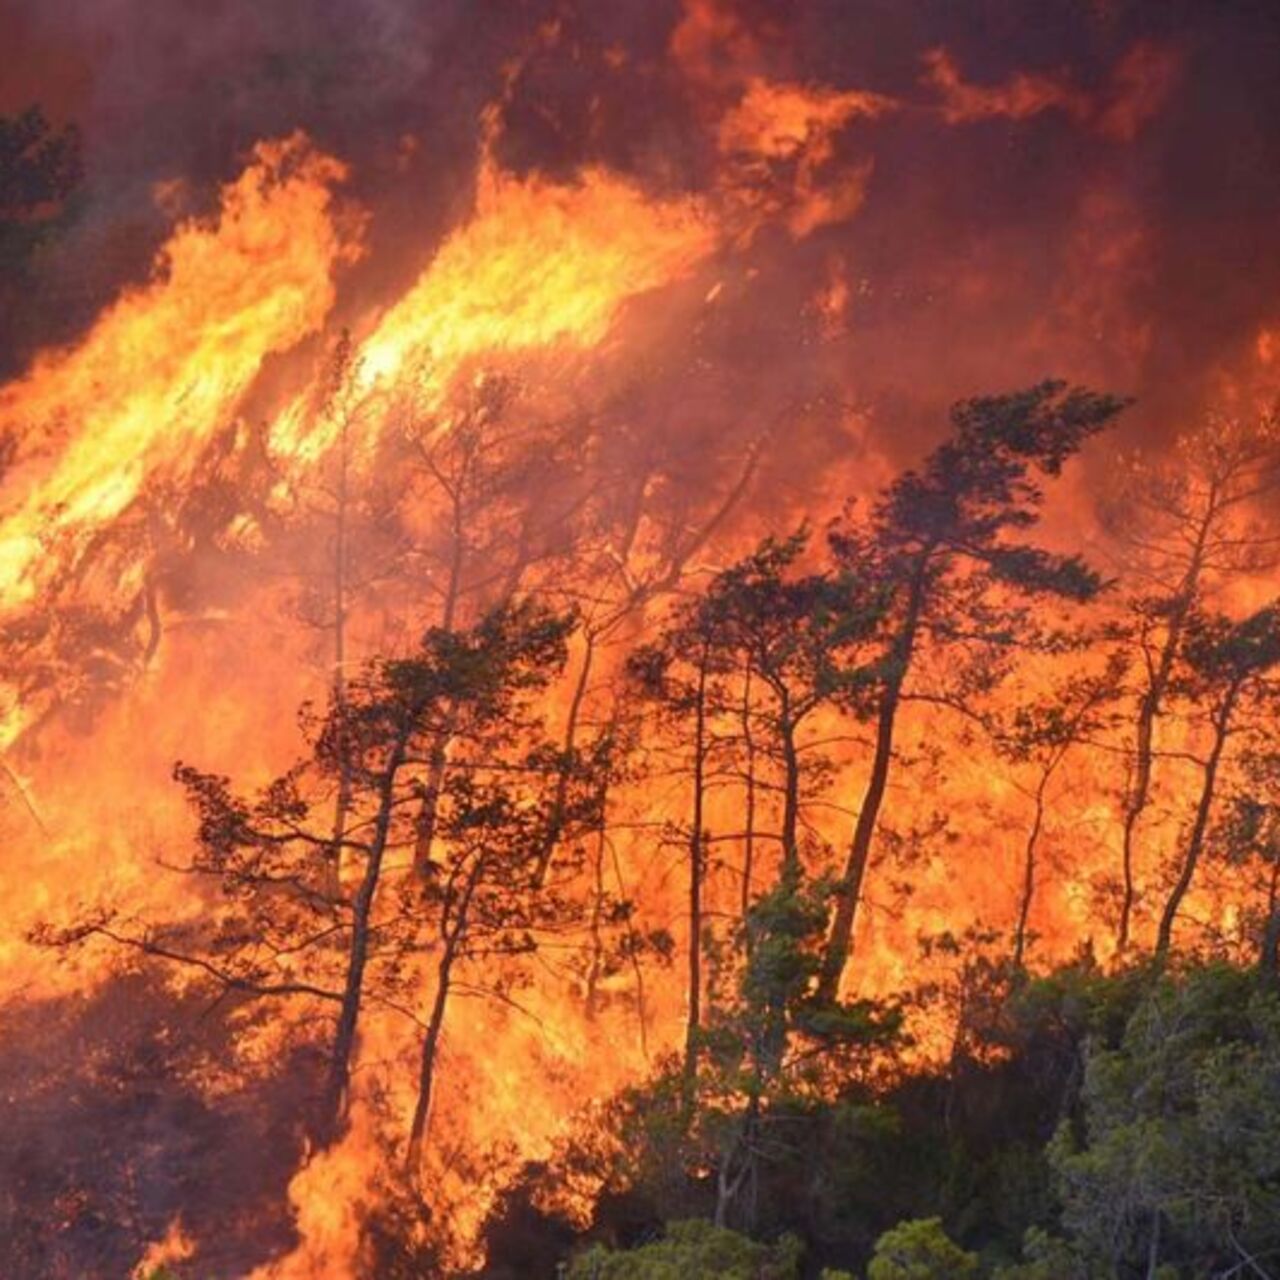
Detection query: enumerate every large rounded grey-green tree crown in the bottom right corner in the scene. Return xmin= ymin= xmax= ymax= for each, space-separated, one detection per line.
xmin=1050 ymin=966 xmax=1280 ymax=1274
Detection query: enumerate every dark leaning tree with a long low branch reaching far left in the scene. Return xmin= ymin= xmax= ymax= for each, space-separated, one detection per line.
xmin=46 ymin=603 xmax=571 ymax=1142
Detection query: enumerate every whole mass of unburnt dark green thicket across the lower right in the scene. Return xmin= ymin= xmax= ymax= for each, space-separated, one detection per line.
xmin=532 ymin=962 xmax=1280 ymax=1280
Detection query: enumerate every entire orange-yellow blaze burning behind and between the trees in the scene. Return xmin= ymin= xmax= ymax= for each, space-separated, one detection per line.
xmin=0 ymin=0 xmax=1276 ymax=1280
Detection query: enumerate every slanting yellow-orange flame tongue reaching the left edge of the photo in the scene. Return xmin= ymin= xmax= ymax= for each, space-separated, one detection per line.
xmin=0 ymin=134 xmax=356 ymax=607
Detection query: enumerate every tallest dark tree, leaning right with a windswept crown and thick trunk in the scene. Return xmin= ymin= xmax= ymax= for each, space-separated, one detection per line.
xmin=820 ymin=381 xmax=1124 ymax=997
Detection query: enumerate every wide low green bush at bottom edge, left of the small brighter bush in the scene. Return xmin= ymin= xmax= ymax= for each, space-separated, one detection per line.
xmin=570 ymin=1220 xmax=800 ymax=1280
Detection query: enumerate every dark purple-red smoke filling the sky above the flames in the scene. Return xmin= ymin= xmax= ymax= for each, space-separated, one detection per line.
xmin=0 ymin=0 xmax=1280 ymax=445
